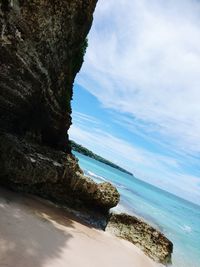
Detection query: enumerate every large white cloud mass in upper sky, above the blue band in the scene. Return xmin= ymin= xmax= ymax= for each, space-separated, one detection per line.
xmin=78 ymin=0 xmax=200 ymax=154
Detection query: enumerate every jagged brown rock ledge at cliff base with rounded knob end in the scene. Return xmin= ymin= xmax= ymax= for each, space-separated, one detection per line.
xmin=0 ymin=134 xmax=119 ymax=212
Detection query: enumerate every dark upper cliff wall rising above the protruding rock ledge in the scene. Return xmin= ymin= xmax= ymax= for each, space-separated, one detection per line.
xmin=0 ymin=0 xmax=97 ymax=150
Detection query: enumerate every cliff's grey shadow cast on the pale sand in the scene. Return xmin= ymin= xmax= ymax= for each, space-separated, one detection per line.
xmin=0 ymin=188 xmax=76 ymax=267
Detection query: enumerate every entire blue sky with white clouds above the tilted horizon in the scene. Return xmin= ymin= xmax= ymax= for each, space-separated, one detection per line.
xmin=69 ymin=0 xmax=200 ymax=205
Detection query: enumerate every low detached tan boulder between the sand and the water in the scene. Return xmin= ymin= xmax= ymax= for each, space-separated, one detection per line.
xmin=106 ymin=214 xmax=173 ymax=264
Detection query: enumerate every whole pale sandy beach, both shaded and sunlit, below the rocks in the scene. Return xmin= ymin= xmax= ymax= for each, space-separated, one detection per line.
xmin=0 ymin=188 xmax=158 ymax=267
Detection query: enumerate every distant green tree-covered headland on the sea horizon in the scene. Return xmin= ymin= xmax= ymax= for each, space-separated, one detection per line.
xmin=70 ymin=140 xmax=133 ymax=176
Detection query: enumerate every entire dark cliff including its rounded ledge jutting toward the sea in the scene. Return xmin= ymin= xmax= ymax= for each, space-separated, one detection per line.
xmin=0 ymin=0 xmax=119 ymax=222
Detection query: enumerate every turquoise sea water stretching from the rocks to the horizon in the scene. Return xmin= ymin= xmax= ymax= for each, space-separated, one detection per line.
xmin=74 ymin=152 xmax=200 ymax=267
